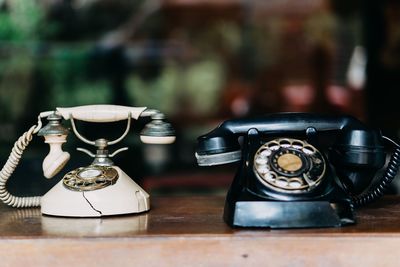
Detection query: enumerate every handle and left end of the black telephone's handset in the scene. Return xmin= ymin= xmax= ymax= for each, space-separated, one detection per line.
xmin=196 ymin=112 xmax=376 ymax=168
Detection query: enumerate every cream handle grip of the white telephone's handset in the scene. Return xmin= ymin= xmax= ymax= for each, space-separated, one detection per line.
xmin=57 ymin=105 xmax=146 ymax=122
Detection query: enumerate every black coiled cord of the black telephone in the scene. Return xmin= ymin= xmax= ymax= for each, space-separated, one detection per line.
xmin=352 ymin=136 xmax=400 ymax=207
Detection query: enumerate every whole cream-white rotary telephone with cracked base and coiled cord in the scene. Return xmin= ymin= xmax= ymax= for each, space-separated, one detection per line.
xmin=0 ymin=105 xmax=175 ymax=217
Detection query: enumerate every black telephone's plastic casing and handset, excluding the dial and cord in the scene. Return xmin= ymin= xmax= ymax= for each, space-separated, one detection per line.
xmin=196 ymin=113 xmax=385 ymax=228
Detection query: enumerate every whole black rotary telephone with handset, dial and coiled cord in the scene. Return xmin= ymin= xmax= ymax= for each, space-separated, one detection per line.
xmin=196 ymin=113 xmax=400 ymax=228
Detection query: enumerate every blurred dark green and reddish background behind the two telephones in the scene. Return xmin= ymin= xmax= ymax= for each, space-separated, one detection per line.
xmin=0 ymin=0 xmax=400 ymax=195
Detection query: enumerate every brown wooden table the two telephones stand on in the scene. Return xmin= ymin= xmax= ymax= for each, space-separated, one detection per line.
xmin=0 ymin=196 xmax=400 ymax=267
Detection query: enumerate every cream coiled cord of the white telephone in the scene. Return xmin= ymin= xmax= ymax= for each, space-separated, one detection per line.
xmin=0 ymin=125 xmax=41 ymax=208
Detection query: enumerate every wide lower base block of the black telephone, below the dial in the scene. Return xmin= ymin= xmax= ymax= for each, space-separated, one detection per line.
xmin=224 ymin=201 xmax=355 ymax=228
